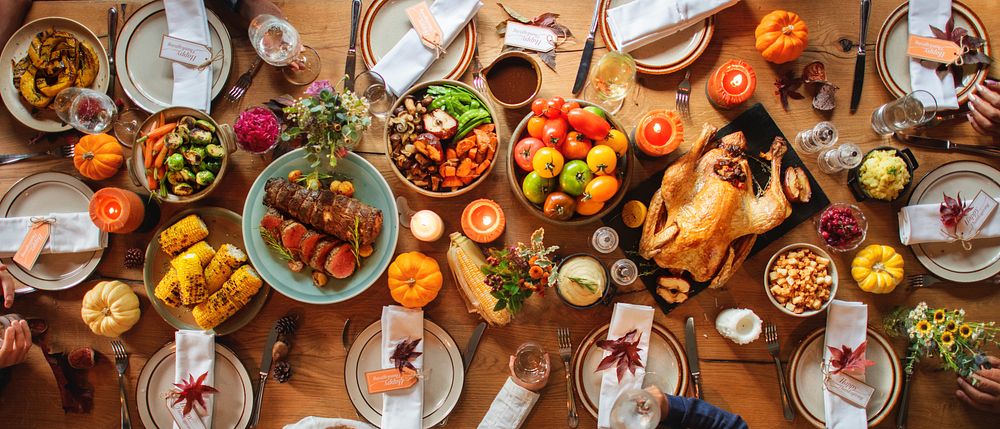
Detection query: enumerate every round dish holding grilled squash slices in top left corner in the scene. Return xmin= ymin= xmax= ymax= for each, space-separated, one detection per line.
xmin=0 ymin=16 xmax=111 ymax=133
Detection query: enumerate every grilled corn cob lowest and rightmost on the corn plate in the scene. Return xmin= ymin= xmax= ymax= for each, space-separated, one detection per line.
xmin=191 ymin=265 xmax=264 ymax=329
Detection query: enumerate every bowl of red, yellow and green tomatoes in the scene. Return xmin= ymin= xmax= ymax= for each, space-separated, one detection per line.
xmin=507 ymin=97 xmax=633 ymax=225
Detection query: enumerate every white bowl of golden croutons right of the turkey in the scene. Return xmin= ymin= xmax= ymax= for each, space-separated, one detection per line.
xmin=764 ymin=243 xmax=837 ymax=317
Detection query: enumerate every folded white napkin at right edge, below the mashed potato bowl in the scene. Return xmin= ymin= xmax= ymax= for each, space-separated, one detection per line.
xmin=898 ymin=198 xmax=1000 ymax=246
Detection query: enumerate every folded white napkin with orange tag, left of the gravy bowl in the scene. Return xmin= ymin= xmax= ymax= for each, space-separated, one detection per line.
xmin=372 ymin=0 xmax=483 ymax=95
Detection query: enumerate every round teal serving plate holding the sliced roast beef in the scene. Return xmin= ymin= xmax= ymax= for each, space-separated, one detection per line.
xmin=243 ymin=149 xmax=399 ymax=304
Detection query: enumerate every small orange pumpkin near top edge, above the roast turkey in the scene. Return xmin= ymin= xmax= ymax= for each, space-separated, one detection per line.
xmin=754 ymin=10 xmax=809 ymax=64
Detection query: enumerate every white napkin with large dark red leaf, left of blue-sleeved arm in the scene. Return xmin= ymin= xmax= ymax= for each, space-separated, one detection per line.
xmin=596 ymin=303 xmax=654 ymax=428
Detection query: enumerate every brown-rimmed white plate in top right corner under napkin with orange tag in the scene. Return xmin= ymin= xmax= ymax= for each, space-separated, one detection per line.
xmin=875 ymin=0 xmax=992 ymax=104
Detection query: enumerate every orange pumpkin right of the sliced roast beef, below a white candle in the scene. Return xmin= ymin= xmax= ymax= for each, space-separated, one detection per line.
xmin=389 ymin=252 xmax=444 ymax=308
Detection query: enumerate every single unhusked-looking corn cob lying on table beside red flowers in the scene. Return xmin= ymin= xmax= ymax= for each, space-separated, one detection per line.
xmin=448 ymin=232 xmax=511 ymax=326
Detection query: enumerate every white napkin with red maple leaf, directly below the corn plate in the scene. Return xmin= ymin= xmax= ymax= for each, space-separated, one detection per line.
xmin=174 ymin=330 xmax=215 ymax=429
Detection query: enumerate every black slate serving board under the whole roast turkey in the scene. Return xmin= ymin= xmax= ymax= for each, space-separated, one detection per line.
xmin=601 ymin=103 xmax=830 ymax=313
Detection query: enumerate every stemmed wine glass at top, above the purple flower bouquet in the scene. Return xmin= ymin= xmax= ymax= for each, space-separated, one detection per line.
xmin=247 ymin=14 xmax=320 ymax=85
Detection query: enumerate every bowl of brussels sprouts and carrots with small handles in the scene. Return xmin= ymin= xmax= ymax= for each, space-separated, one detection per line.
xmin=128 ymin=107 xmax=236 ymax=203
